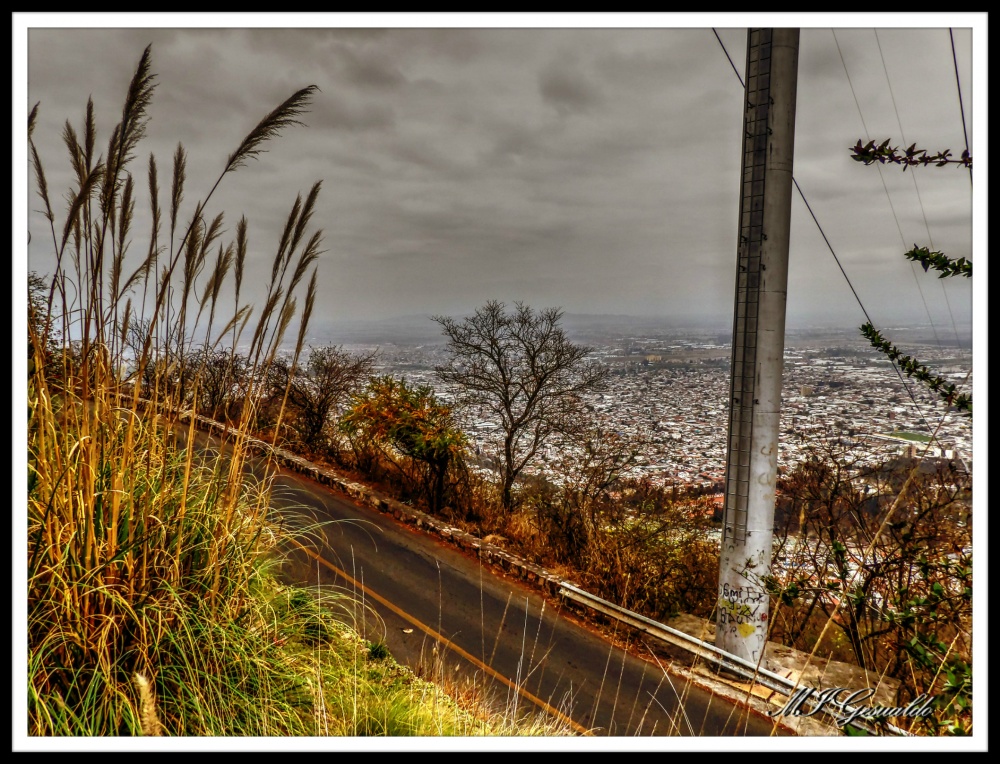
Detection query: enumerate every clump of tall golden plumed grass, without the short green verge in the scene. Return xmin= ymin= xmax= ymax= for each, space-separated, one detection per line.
xmin=28 ymin=41 xmax=321 ymax=734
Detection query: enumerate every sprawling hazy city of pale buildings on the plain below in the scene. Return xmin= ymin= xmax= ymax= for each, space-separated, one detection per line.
xmin=286 ymin=316 xmax=972 ymax=491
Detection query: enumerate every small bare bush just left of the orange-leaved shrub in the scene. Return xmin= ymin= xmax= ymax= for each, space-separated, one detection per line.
xmin=271 ymin=346 xmax=375 ymax=448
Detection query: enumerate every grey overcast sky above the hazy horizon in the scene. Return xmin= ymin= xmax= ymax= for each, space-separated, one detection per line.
xmin=15 ymin=14 xmax=985 ymax=338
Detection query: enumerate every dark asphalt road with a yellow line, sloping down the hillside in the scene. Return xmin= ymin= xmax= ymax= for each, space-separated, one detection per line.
xmin=189 ymin=430 xmax=773 ymax=737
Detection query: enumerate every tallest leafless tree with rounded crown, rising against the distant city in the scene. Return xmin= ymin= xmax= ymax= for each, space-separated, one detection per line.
xmin=434 ymin=300 xmax=607 ymax=510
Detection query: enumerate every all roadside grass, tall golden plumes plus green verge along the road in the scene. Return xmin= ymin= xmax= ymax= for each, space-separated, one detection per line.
xmin=26 ymin=48 xmax=536 ymax=736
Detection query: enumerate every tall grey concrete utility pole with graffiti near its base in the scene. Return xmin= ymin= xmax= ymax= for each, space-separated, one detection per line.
xmin=716 ymin=29 xmax=799 ymax=665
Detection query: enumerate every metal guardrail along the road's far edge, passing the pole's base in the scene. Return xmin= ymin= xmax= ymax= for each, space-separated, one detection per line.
xmin=559 ymin=582 xmax=913 ymax=737
